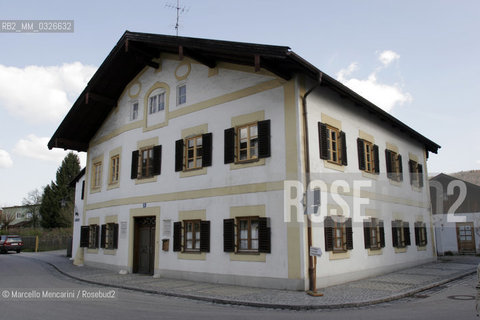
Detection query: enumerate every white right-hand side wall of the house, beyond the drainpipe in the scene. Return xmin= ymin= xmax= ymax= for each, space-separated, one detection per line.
xmin=308 ymin=87 xmax=434 ymax=286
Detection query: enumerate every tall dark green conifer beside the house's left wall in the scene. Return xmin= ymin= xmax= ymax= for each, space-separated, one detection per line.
xmin=40 ymin=152 xmax=80 ymax=228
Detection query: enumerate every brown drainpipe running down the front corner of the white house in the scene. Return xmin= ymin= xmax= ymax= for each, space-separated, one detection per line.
xmin=302 ymin=72 xmax=323 ymax=295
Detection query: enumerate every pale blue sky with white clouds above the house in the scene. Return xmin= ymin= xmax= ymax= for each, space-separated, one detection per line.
xmin=0 ymin=0 xmax=480 ymax=207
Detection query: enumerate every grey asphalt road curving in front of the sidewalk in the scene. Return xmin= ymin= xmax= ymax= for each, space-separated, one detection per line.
xmin=0 ymin=253 xmax=480 ymax=320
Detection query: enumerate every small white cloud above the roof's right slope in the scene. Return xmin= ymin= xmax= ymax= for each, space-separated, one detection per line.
xmin=337 ymin=50 xmax=412 ymax=112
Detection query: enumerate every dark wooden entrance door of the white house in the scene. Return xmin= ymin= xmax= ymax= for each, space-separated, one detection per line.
xmin=133 ymin=217 xmax=155 ymax=275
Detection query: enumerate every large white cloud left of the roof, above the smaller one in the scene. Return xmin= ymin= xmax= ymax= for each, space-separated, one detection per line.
xmin=0 ymin=62 xmax=96 ymax=123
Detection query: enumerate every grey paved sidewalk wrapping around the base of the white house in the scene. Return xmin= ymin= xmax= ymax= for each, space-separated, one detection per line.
xmin=17 ymin=251 xmax=480 ymax=310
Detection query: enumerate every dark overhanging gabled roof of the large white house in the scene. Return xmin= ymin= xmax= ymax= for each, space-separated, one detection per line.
xmin=48 ymin=31 xmax=440 ymax=153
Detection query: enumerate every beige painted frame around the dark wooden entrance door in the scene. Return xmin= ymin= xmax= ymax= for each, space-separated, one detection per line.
xmin=128 ymin=207 xmax=160 ymax=276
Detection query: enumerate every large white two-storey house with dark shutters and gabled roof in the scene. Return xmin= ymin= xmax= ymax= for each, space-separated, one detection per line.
xmin=49 ymin=31 xmax=439 ymax=290
